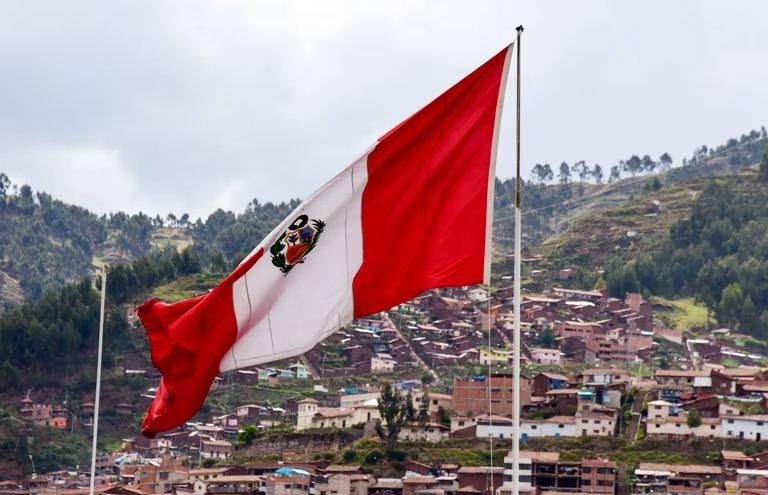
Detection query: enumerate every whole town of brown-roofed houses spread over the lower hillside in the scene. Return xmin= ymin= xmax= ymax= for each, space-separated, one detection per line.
xmin=12 ymin=288 xmax=768 ymax=495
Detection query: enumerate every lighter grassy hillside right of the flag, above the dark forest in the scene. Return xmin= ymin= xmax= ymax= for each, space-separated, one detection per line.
xmin=494 ymin=131 xmax=768 ymax=280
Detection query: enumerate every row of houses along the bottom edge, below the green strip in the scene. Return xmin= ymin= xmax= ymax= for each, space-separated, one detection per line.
xmin=10 ymin=450 xmax=768 ymax=495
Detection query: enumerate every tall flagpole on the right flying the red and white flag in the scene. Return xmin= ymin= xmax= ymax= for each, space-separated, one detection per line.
xmin=512 ymin=26 xmax=523 ymax=495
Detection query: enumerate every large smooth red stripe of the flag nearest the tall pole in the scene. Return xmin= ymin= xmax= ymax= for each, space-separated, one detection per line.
xmin=353 ymin=48 xmax=509 ymax=317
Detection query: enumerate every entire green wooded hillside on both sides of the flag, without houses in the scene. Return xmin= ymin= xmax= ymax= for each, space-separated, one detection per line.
xmin=0 ymin=127 xmax=768 ymax=469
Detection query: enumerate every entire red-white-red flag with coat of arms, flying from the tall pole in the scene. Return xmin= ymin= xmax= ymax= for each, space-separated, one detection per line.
xmin=138 ymin=45 xmax=512 ymax=436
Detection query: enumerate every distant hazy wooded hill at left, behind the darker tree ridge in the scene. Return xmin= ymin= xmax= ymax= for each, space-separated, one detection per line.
xmin=0 ymin=180 xmax=297 ymax=312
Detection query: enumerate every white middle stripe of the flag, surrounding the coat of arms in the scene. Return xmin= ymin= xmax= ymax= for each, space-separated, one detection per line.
xmin=220 ymin=150 xmax=370 ymax=371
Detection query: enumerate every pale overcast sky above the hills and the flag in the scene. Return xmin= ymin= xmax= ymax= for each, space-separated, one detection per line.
xmin=0 ymin=0 xmax=768 ymax=217
